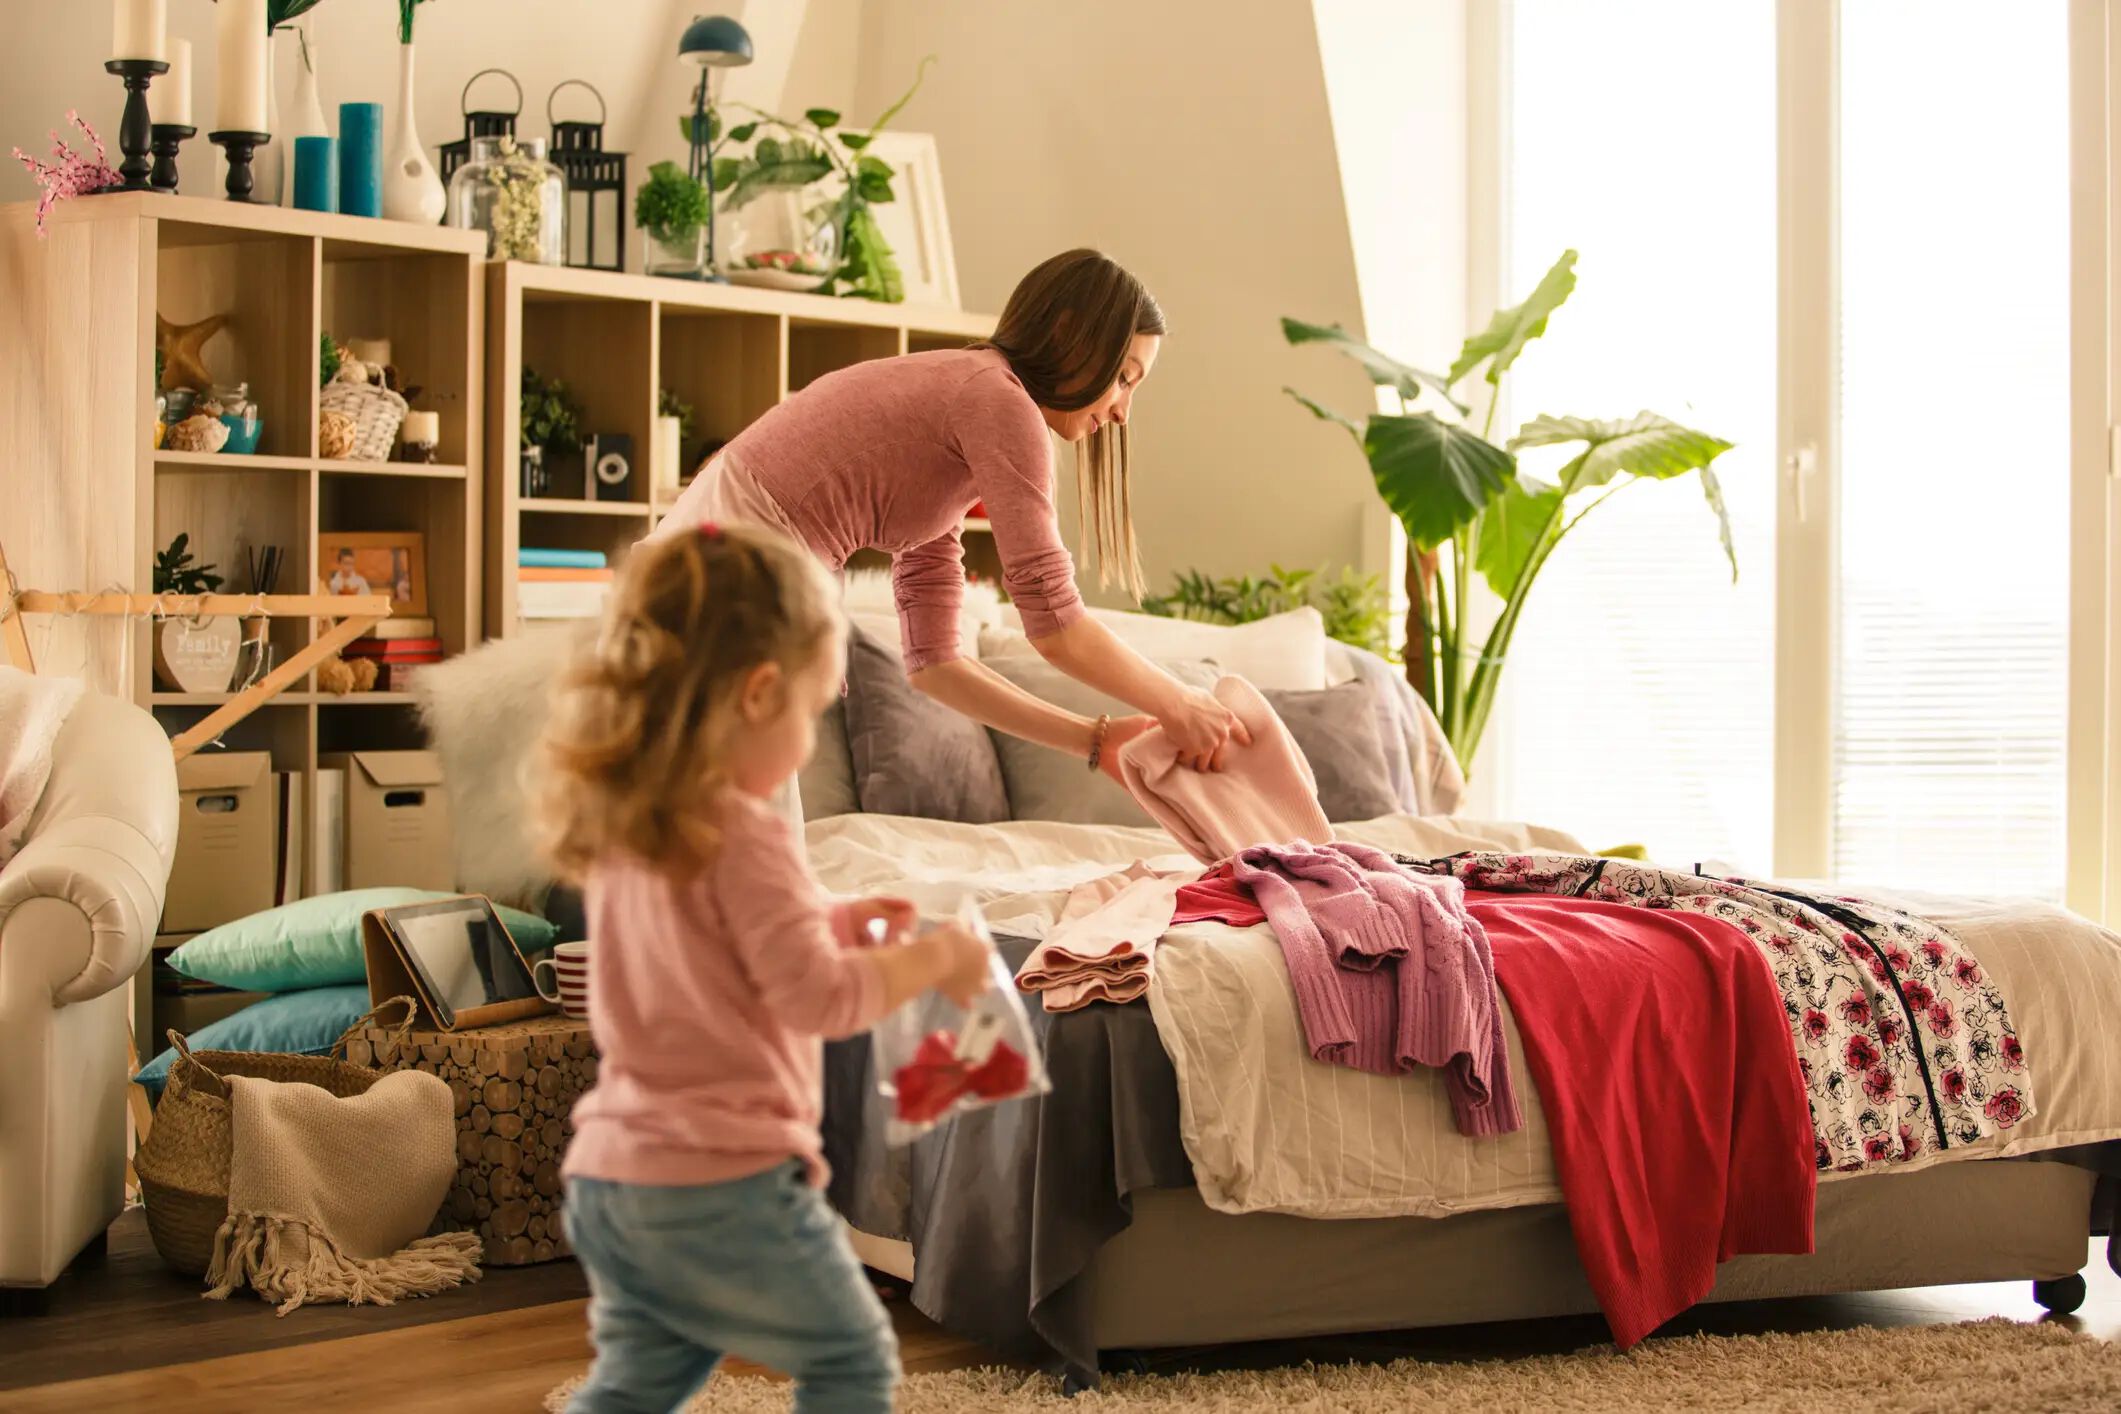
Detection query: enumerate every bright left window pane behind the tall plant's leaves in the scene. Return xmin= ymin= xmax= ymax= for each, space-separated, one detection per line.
xmin=1476 ymin=0 xmax=1775 ymax=871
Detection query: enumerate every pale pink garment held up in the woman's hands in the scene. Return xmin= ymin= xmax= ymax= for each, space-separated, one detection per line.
xmin=1120 ymin=676 xmax=1332 ymax=865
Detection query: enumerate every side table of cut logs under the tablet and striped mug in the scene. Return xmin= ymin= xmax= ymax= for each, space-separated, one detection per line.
xmin=346 ymin=1015 xmax=596 ymax=1266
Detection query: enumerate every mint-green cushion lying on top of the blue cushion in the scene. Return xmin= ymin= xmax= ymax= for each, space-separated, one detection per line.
xmin=168 ymin=888 xmax=554 ymax=992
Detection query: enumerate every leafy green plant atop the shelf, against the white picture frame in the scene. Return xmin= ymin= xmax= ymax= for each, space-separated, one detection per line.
xmin=679 ymin=55 xmax=933 ymax=305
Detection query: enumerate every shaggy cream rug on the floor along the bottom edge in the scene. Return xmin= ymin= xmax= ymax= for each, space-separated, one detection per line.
xmin=545 ymin=1319 xmax=2121 ymax=1414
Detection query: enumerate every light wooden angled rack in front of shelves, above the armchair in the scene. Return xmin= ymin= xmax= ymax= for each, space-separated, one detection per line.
xmin=0 ymin=536 xmax=390 ymax=761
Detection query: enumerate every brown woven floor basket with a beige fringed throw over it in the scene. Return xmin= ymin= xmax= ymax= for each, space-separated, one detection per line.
xmin=134 ymin=996 xmax=418 ymax=1276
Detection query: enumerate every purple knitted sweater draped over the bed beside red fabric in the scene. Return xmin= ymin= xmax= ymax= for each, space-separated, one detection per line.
xmin=1232 ymin=844 xmax=1525 ymax=1134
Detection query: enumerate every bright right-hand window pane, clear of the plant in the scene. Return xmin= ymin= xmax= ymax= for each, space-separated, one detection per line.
xmin=1833 ymin=0 xmax=2070 ymax=899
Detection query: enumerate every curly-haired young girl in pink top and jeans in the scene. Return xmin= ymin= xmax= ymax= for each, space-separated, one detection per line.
xmin=539 ymin=526 xmax=988 ymax=1414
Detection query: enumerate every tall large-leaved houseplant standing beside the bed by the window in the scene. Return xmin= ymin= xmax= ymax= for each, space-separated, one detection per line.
xmin=1281 ymin=250 xmax=1737 ymax=776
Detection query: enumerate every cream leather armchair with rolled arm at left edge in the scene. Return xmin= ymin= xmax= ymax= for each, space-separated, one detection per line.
xmin=0 ymin=693 xmax=176 ymax=1306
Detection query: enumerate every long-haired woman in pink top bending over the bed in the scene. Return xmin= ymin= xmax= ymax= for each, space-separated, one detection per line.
xmin=655 ymin=250 xmax=1247 ymax=778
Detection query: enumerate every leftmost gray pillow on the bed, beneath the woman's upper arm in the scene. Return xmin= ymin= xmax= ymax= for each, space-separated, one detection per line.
xmin=846 ymin=628 xmax=1010 ymax=825
